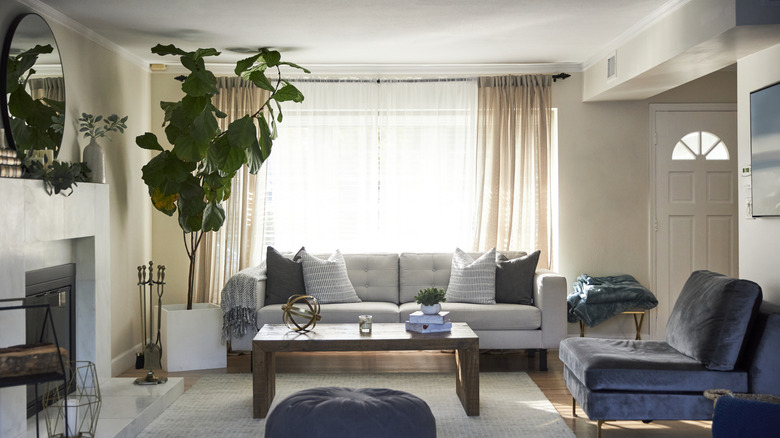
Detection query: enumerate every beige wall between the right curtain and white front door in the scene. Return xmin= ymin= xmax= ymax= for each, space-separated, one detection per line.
xmin=553 ymin=69 xmax=736 ymax=337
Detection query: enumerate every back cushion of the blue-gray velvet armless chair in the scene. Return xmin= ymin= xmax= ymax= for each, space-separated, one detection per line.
xmin=666 ymin=271 xmax=761 ymax=371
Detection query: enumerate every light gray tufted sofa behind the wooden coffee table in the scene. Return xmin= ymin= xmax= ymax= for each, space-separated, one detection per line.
xmin=223 ymin=252 xmax=567 ymax=369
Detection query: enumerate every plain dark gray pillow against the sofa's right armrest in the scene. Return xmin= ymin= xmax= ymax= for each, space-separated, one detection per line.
xmin=496 ymin=250 xmax=540 ymax=306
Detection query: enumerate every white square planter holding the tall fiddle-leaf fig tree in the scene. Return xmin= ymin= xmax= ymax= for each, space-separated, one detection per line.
xmin=160 ymin=303 xmax=227 ymax=371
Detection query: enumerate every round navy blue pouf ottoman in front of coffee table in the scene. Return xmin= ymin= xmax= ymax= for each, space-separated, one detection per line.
xmin=265 ymin=387 xmax=436 ymax=438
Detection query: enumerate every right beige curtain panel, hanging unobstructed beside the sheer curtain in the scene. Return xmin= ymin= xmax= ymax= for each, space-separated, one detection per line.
xmin=475 ymin=75 xmax=552 ymax=267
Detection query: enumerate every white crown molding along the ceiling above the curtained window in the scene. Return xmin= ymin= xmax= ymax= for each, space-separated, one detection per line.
xmin=152 ymin=63 xmax=582 ymax=77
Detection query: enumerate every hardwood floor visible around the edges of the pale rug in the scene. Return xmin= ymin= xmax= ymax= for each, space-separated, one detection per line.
xmin=121 ymin=350 xmax=712 ymax=438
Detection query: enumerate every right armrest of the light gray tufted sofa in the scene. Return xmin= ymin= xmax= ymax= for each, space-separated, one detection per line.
xmin=534 ymin=269 xmax=566 ymax=348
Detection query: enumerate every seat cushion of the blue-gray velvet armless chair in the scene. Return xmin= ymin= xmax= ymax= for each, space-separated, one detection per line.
xmin=559 ymin=338 xmax=748 ymax=393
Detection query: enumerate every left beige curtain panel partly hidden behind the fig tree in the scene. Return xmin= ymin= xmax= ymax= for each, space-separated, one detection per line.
xmin=194 ymin=77 xmax=270 ymax=304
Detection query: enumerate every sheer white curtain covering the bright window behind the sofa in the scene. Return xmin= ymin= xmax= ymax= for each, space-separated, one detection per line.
xmin=255 ymin=79 xmax=477 ymax=260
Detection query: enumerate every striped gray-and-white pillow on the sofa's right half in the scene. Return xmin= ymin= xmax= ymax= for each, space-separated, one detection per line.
xmin=445 ymin=248 xmax=496 ymax=304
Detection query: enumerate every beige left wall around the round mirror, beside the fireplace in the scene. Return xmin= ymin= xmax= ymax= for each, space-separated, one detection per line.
xmin=0 ymin=2 xmax=151 ymax=375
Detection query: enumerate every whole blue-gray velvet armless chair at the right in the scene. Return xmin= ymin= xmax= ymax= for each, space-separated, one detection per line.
xmin=559 ymin=271 xmax=780 ymax=436
